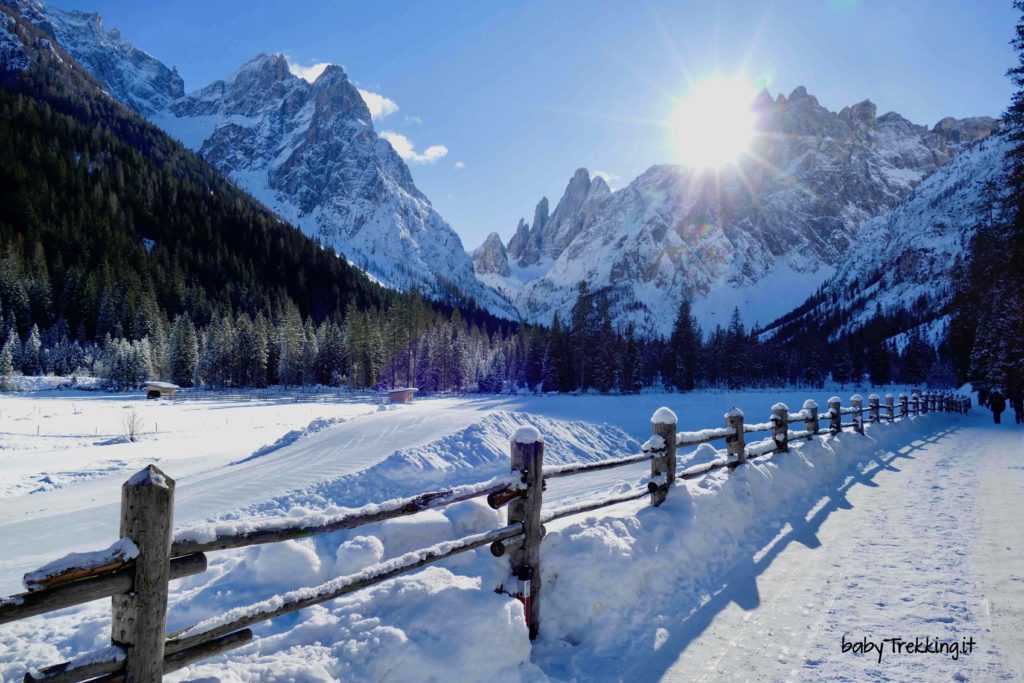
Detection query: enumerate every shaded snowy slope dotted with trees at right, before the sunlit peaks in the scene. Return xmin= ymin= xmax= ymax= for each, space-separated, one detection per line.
xmin=765 ymin=134 xmax=1012 ymax=350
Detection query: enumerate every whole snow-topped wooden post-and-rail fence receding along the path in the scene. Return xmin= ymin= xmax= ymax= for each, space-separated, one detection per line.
xmin=0 ymin=392 xmax=971 ymax=682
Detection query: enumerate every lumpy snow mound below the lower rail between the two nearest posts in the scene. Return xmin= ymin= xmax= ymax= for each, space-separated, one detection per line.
xmin=167 ymin=567 xmax=545 ymax=683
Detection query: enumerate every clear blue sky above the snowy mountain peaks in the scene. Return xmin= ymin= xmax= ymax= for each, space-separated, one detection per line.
xmin=51 ymin=0 xmax=1016 ymax=249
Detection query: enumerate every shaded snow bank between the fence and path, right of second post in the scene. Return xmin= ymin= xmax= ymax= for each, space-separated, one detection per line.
xmin=535 ymin=421 xmax=938 ymax=680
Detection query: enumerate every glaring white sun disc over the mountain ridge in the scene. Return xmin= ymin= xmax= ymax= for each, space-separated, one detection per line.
xmin=668 ymin=77 xmax=757 ymax=169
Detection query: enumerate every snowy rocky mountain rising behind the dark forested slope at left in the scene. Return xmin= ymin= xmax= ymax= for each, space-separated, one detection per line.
xmin=6 ymin=0 xmax=514 ymax=315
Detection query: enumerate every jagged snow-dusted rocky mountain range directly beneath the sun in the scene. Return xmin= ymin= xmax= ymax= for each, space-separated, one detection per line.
xmin=475 ymin=87 xmax=997 ymax=334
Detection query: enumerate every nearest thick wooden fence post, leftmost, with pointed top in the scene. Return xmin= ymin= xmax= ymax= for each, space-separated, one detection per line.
xmin=111 ymin=465 xmax=174 ymax=682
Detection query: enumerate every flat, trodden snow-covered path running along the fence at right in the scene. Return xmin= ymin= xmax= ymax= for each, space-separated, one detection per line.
xmin=647 ymin=418 xmax=1024 ymax=681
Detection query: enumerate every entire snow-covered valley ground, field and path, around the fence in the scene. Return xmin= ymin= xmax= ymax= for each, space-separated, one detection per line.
xmin=0 ymin=388 xmax=1024 ymax=681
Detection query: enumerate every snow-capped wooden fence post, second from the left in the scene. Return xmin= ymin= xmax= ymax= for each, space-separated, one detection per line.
xmin=508 ymin=426 xmax=544 ymax=640
